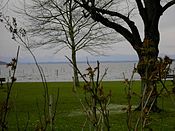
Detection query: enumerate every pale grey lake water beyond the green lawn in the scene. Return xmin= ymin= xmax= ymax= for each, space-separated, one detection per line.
xmin=0 ymin=62 xmax=175 ymax=82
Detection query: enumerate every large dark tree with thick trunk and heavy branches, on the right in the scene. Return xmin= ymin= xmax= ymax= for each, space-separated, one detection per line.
xmin=74 ymin=0 xmax=175 ymax=111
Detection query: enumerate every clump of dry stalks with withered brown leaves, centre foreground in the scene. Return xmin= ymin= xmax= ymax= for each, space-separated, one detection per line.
xmin=67 ymin=57 xmax=111 ymax=131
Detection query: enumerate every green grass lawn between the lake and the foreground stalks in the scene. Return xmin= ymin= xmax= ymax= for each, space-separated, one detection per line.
xmin=0 ymin=81 xmax=175 ymax=131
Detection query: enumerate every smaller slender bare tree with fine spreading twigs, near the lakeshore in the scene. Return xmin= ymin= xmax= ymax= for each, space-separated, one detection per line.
xmin=17 ymin=0 xmax=116 ymax=85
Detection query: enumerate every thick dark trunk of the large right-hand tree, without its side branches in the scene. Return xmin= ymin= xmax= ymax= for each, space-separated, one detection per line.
xmin=134 ymin=0 xmax=162 ymax=112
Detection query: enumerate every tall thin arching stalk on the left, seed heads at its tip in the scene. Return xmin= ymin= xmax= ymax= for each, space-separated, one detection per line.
xmin=0 ymin=15 xmax=59 ymax=131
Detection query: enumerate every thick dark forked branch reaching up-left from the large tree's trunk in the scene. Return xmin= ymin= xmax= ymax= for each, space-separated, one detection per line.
xmin=75 ymin=0 xmax=141 ymax=49
